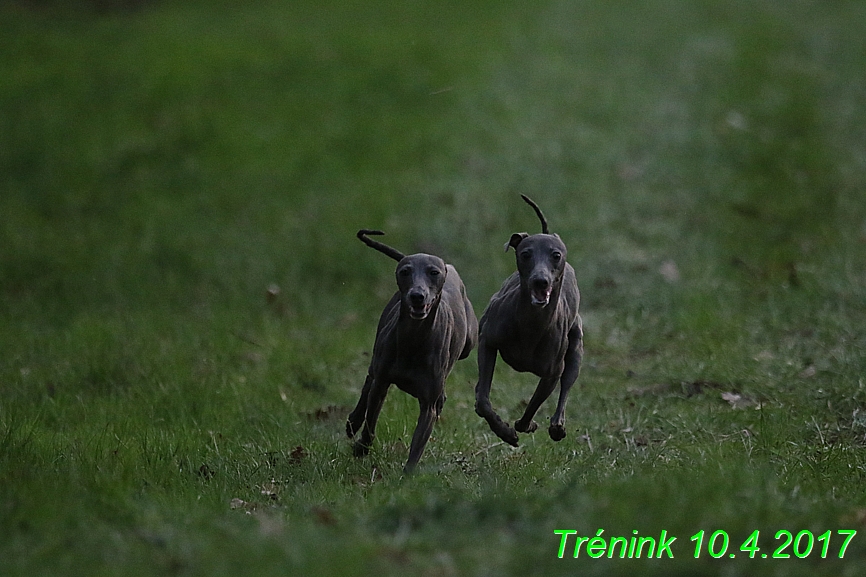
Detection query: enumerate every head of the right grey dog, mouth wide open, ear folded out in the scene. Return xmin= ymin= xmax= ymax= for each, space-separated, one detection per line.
xmin=505 ymin=232 xmax=567 ymax=307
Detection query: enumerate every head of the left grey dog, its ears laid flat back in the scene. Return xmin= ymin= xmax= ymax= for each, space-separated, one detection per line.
xmin=396 ymin=254 xmax=448 ymax=320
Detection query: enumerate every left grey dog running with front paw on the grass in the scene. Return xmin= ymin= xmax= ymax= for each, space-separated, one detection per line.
xmin=346 ymin=230 xmax=478 ymax=472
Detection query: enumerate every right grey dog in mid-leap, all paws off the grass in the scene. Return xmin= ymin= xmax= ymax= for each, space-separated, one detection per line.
xmin=475 ymin=195 xmax=583 ymax=447
